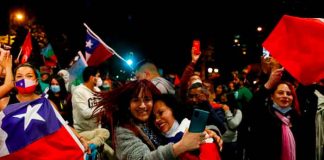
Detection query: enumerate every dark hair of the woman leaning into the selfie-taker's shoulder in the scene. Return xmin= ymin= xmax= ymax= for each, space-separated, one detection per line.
xmin=154 ymin=94 xmax=188 ymax=123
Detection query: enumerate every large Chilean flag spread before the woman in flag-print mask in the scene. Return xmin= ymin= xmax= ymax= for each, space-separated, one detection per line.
xmin=0 ymin=97 xmax=85 ymax=160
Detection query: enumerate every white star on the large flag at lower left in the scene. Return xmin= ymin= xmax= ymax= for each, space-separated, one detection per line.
xmin=13 ymin=103 xmax=45 ymax=130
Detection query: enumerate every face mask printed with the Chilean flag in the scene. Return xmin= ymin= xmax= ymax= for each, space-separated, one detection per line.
xmin=16 ymin=79 xmax=36 ymax=94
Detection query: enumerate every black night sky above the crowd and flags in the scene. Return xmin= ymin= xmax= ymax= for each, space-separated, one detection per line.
xmin=0 ymin=0 xmax=324 ymax=77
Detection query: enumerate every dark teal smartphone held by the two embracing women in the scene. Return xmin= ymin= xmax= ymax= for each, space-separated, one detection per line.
xmin=189 ymin=108 xmax=209 ymax=133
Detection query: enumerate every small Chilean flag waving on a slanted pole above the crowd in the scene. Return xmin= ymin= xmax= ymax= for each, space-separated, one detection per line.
xmin=85 ymin=30 xmax=114 ymax=66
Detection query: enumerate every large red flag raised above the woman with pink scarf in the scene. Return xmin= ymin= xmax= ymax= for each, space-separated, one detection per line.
xmin=263 ymin=15 xmax=324 ymax=85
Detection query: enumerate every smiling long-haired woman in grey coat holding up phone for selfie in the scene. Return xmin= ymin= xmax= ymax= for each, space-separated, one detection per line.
xmin=95 ymin=80 xmax=204 ymax=160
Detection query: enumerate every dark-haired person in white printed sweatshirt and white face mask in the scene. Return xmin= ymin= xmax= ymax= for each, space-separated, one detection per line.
xmin=72 ymin=66 xmax=114 ymax=158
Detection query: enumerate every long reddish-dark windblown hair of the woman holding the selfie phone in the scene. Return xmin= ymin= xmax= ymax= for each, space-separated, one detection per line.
xmin=94 ymin=79 xmax=161 ymax=147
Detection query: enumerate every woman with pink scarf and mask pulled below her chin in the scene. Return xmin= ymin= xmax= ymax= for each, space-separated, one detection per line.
xmin=249 ymin=68 xmax=307 ymax=160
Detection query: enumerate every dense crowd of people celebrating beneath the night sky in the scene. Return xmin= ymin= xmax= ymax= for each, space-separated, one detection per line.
xmin=0 ymin=42 xmax=324 ymax=160
